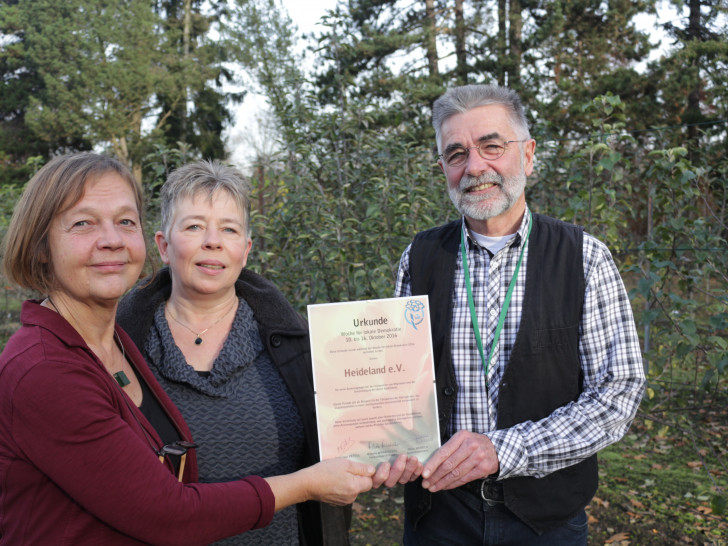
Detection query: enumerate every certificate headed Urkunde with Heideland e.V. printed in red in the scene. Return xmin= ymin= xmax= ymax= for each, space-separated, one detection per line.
xmin=308 ymin=296 xmax=440 ymax=464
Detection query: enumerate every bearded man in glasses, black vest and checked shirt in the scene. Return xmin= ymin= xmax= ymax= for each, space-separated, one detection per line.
xmin=396 ymin=85 xmax=645 ymax=546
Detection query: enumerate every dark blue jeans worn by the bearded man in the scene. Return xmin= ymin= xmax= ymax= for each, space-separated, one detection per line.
xmin=404 ymin=482 xmax=588 ymax=546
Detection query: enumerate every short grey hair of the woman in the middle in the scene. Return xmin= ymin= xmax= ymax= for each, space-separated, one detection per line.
xmin=160 ymin=160 xmax=252 ymax=238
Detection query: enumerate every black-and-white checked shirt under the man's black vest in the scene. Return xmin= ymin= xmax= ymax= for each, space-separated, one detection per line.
xmin=395 ymin=208 xmax=645 ymax=478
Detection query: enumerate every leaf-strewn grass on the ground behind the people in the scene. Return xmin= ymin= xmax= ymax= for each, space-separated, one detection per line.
xmin=350 ymin=395 xmax=728 ymax=546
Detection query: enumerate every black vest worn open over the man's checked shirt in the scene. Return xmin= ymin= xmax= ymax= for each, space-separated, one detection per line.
xmin=405 ymin=214 xmax=598 ymax=534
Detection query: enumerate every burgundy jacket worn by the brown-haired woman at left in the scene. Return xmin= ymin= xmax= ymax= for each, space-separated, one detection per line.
xmin=0 ymin=301 xmax=275 ymax=546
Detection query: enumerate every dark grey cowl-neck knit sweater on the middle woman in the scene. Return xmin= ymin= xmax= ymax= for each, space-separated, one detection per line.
xmin=149 ymin=300 xmax=303 ymax=545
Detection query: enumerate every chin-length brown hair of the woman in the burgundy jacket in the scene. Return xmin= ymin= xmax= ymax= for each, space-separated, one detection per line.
xmin=3 ymin=153 xmax=144 ymax=294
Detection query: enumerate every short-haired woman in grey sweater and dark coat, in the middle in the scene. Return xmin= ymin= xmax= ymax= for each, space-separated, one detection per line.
xmin=117 ymin=162 xmax=421 ymax=545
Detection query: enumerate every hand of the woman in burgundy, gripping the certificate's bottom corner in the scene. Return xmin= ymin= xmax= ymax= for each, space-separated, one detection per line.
xmin=265 ymin=459 xmax=375 ymax=511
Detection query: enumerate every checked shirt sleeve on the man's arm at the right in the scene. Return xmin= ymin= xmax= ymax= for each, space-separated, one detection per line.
xmin=488 ymin=234 xmax=645 ymax=479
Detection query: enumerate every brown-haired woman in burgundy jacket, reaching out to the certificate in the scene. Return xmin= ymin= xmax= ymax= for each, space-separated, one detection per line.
xmin=0 ymin=154 xmax=374 ymax=545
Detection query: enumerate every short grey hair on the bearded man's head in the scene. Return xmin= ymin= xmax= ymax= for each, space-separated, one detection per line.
xmin=432 ymin=85 xmax=531 ymax=152
